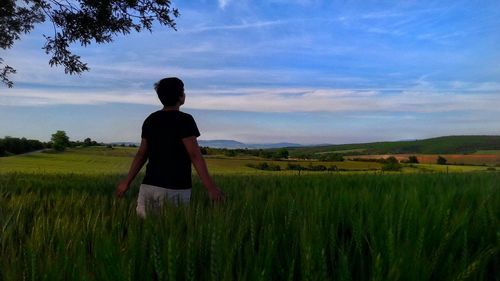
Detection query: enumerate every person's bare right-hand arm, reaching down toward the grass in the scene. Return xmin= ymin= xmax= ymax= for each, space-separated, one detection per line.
xmin=182 ymin=136 xmax=223 ymax=201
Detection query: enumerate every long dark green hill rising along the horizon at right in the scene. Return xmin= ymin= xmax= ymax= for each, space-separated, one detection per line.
xmin=290 ymin=136 xmax=500 ymax=157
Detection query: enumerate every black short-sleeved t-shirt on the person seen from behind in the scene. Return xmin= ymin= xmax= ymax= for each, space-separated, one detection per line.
xmin=141 ymin=110 xmax=200 ymax=189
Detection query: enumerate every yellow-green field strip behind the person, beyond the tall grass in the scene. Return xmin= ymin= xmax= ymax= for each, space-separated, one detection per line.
xmin=0 ymin=147 xmax=381 ymax=175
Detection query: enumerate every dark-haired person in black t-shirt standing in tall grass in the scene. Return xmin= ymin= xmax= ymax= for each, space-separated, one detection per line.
xmin=116 ymin=77 xmax=223 ymax=218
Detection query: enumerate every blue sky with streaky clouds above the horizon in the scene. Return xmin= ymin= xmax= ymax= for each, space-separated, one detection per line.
xmin=0 ymin=0 xmax=500 ymax=144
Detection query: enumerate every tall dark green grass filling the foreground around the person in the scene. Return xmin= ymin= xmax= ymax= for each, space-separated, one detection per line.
xmin=0 ymin=173 xmax=500 ymax=281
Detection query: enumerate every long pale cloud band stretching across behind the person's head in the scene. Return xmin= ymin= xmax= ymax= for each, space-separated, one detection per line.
xmin=4 ymin=83 xmax=500 ymax=113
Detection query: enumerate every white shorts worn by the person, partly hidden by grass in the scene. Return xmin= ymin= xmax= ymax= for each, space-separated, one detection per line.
xmin=136 ymin=184 xmax=191 ymax=218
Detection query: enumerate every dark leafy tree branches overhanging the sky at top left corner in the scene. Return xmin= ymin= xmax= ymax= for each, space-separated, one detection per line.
xmin=0 ymin=0 xmax=179 ymax=87
